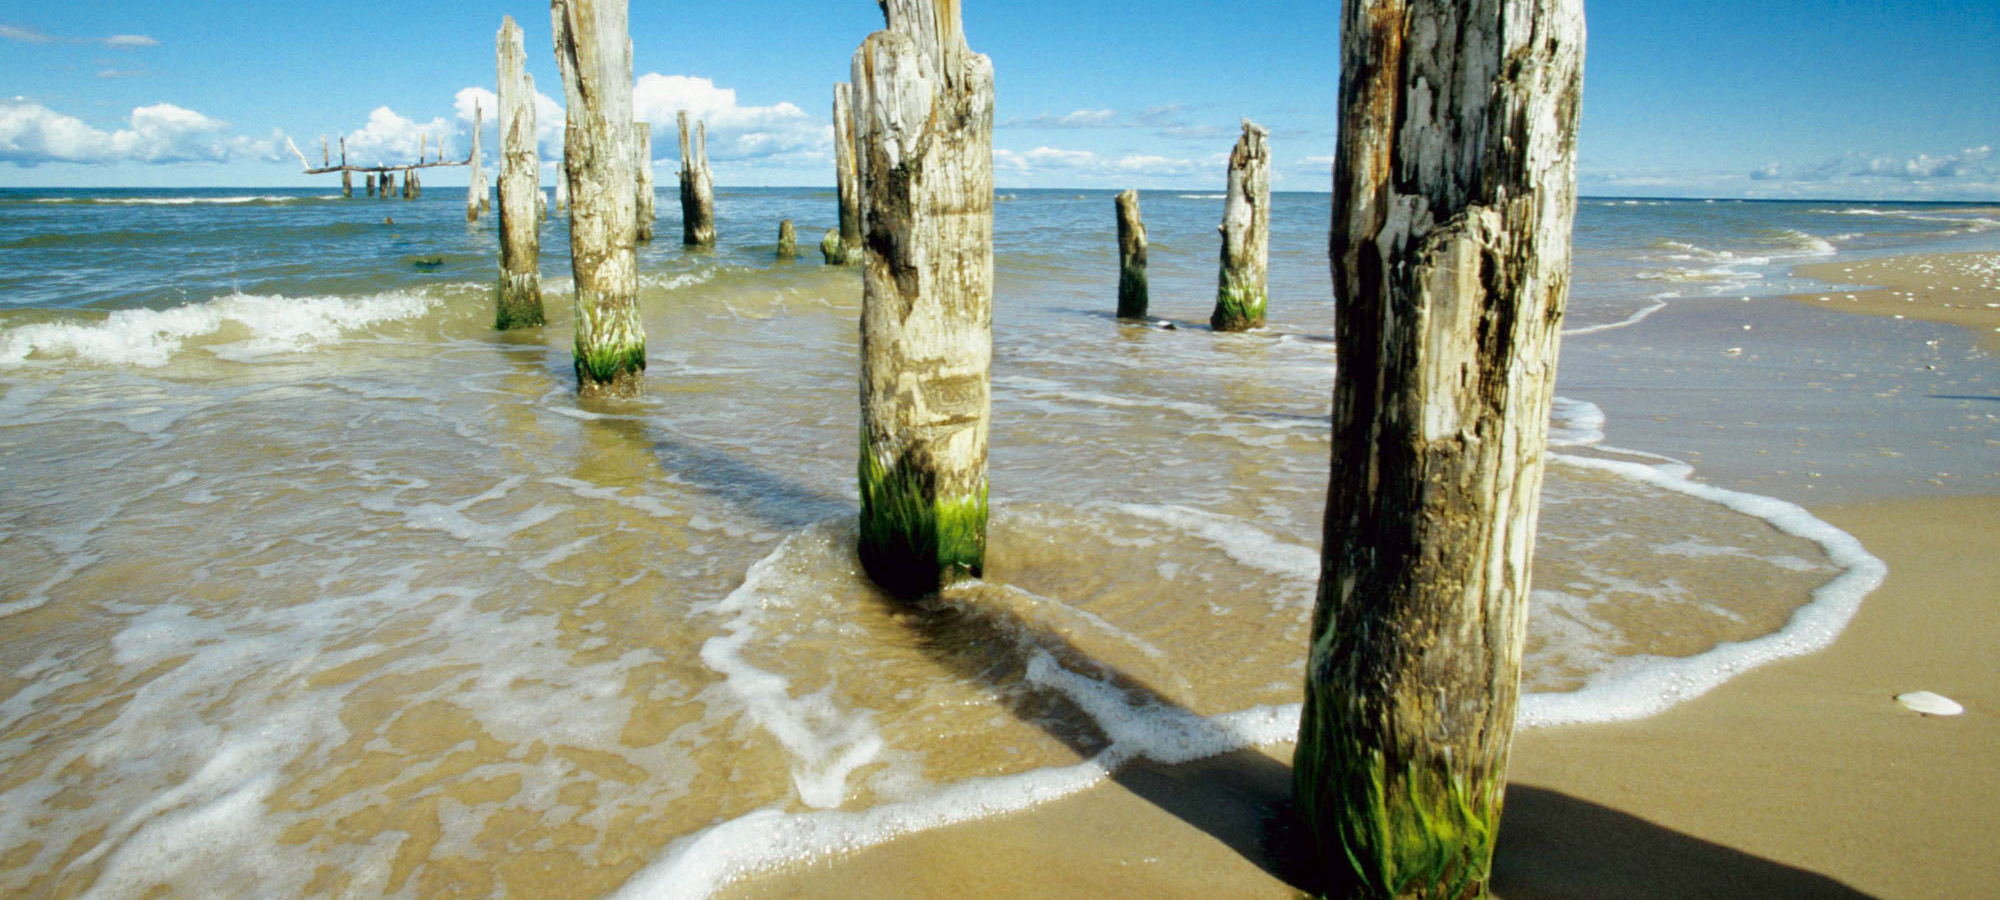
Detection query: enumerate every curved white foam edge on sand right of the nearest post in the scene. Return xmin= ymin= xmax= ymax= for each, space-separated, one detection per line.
xmin=1518 ymin=450 xmax=1888 ymax=728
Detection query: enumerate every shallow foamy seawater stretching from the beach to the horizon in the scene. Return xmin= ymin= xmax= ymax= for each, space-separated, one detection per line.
xmin=0 ymin=188 xmax=2000 ymax=898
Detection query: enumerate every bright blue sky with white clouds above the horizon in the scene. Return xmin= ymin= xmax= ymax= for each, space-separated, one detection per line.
xmin=0 ymin=0 xmax=2000 ymax=200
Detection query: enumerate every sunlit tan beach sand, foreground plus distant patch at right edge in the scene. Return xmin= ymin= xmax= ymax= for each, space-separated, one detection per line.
xmin=722 ymin=254 xmax=2000 ymax=900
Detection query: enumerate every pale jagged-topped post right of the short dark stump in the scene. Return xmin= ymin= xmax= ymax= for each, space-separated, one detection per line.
xmin=1208 ymin=119 xmax=1272 ymax=332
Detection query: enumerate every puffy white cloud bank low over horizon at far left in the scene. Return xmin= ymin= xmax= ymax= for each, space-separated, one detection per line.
xmin=0 ymin=98 xmax=276 ymax=166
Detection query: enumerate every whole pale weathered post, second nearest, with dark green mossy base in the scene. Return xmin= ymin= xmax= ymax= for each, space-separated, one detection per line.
xmin=854 ymin=0 xmax=994 ymax=598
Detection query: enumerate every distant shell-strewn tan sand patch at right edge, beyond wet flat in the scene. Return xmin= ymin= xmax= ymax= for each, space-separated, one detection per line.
xmin=1792 ymin=252 xmax=2000 ymax=354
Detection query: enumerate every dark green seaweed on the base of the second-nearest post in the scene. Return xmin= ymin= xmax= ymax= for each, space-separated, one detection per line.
xmin=858 ymin=448 xmax=986 ymax=600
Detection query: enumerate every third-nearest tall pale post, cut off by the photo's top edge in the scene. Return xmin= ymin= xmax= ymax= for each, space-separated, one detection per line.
xmin=550 ymin=0 xmax=646 ymax=396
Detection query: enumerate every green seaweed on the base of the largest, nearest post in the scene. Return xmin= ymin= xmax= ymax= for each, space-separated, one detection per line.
xmin=1292 ymin=710 xmax=1500 ymax=900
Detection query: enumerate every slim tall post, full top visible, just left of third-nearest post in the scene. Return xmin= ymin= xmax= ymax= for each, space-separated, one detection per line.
xmin=494 ymin=16 xmax=544 ymax=330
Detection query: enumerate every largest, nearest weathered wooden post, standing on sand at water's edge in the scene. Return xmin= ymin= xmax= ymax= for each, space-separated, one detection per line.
xmin=1294 ymin=0 xmax=1584 ymax=898
